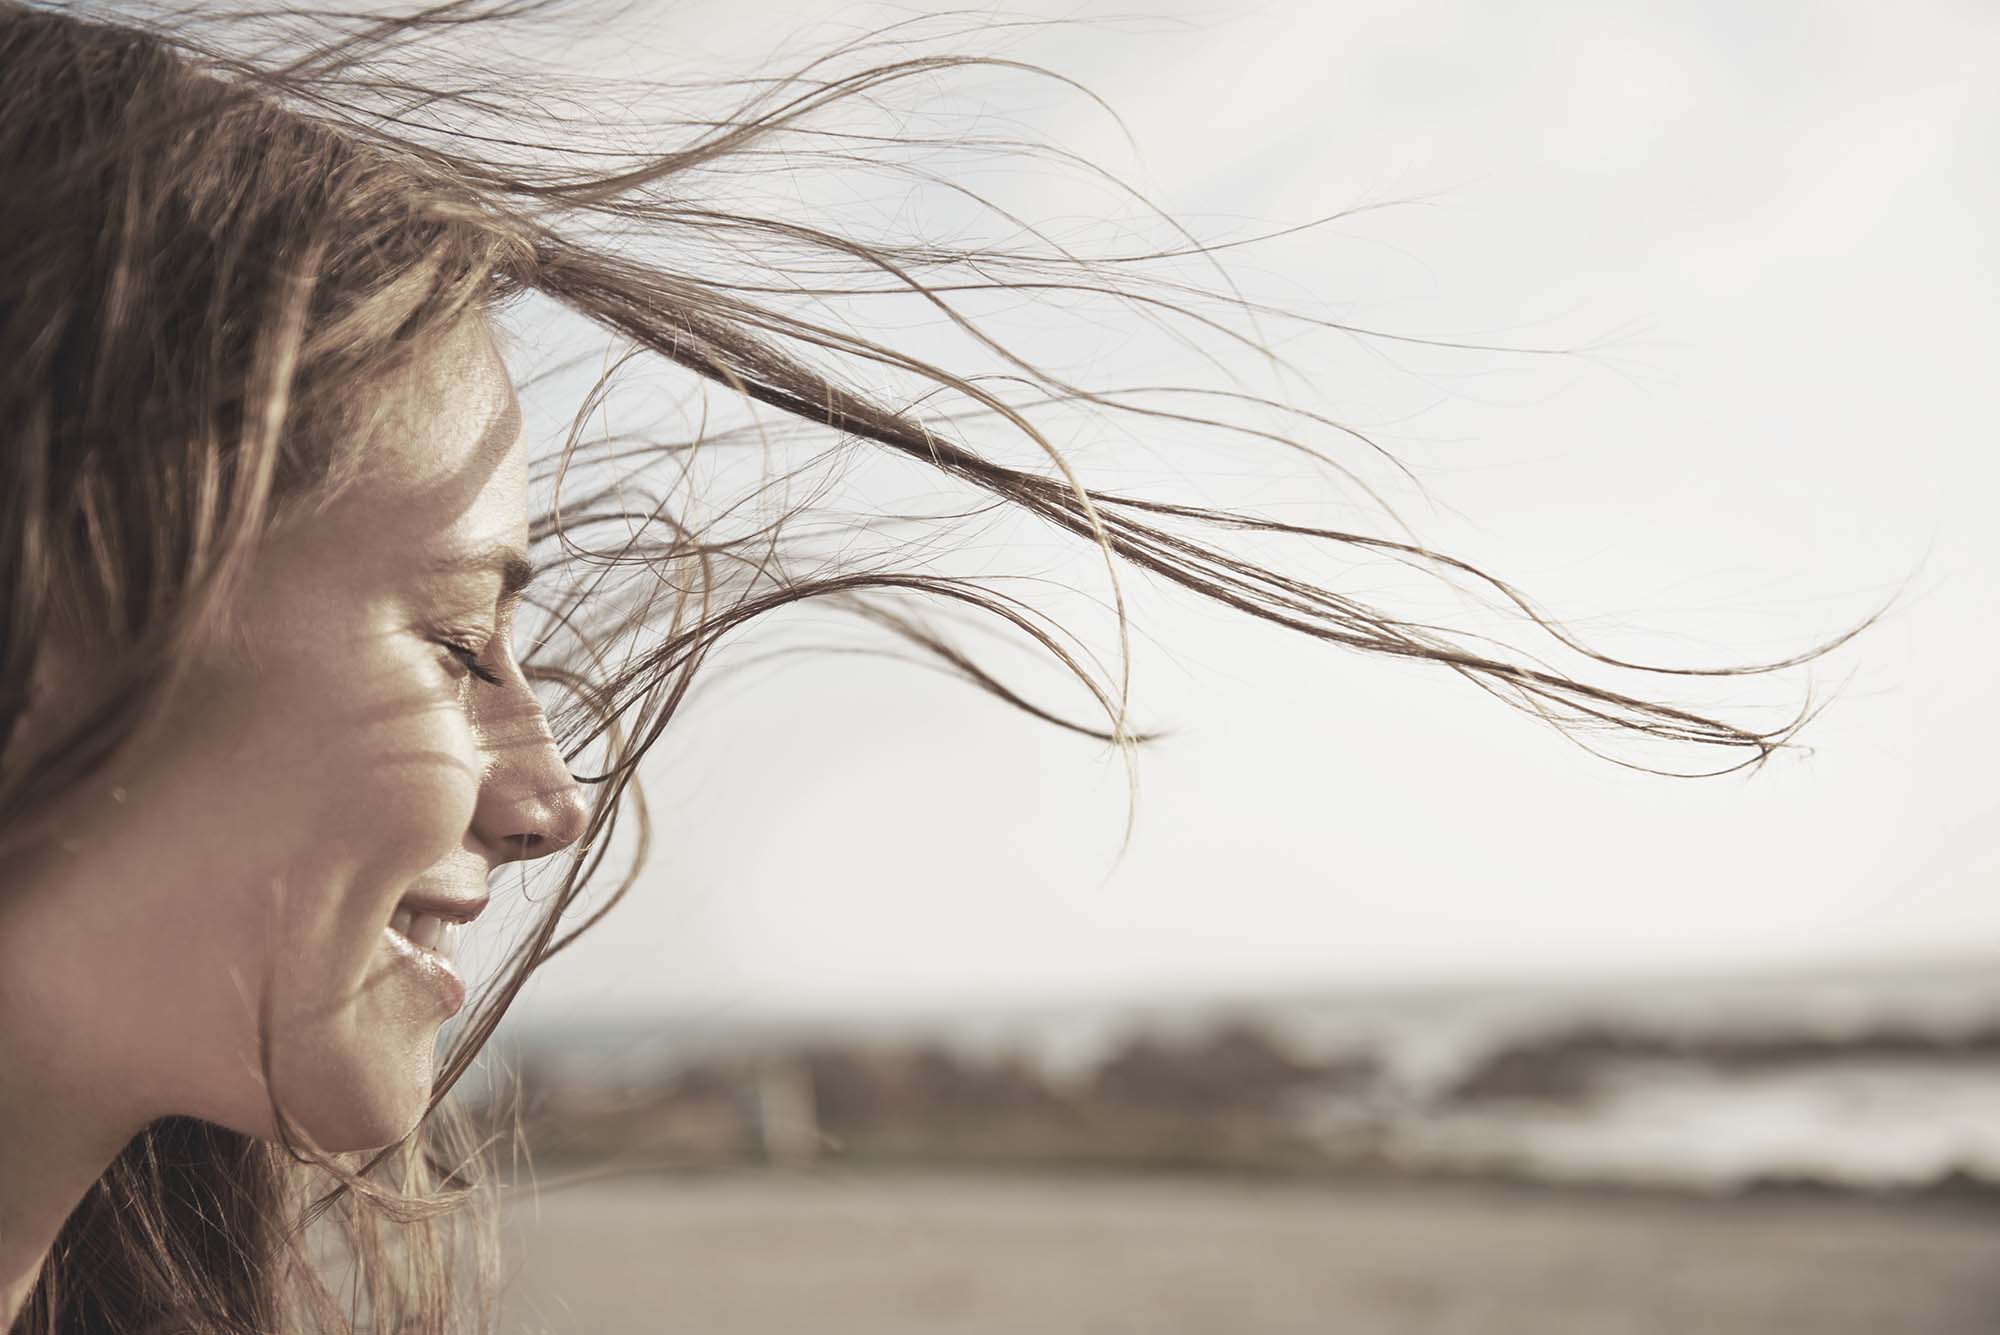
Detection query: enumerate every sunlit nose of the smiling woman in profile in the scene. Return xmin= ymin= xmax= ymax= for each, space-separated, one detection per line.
xmin=472 ymin=689 xmax=590 ymax=865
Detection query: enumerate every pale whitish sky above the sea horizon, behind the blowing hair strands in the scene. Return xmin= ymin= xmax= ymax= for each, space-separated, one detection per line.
xmin=454 ymin=0 xmax=2000 ymax=1019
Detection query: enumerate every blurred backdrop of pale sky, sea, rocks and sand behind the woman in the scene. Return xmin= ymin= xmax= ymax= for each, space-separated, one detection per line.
xmin=430 ymin=0 xmax=2000 ymax=1335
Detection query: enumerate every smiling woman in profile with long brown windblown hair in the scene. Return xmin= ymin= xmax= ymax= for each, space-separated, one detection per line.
xmin=0 ymin=0 xmax=1852 ymax=1335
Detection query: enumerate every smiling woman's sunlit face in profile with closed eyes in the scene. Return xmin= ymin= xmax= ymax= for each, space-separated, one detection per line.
xmin=0 ymin=320 xmax=584 ymax=1149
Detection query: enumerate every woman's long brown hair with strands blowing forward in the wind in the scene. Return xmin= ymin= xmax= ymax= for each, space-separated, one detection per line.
xmin=0 ymin=0 xmax=1866 ymax=1335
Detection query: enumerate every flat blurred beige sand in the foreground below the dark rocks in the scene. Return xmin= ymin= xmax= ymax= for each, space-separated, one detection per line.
xmin=502 ymin=1173 xmax=2000 ymax=1335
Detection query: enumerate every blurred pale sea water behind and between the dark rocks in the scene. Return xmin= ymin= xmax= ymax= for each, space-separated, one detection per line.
xmin=504 ymin=961 xmax=2000 ymax=1191
